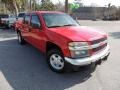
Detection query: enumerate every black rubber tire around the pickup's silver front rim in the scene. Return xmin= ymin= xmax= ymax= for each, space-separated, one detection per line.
xmin=47 ymin=49 xmax=66 ymax=73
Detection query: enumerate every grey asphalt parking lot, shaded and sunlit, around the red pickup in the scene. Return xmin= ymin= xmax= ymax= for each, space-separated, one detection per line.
xmin=0 ymin=21 xmax=120 ymax=90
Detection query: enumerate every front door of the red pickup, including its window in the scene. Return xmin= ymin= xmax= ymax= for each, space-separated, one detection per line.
xmin=30 ymin=14 xmax=45 ymax=51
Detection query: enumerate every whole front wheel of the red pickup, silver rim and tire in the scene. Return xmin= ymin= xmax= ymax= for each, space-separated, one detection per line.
xmin=47 ymin=49 xmax=65 ymax=73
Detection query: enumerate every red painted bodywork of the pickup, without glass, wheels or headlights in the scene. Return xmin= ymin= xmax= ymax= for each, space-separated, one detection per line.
xmin=15 ymin=11 xmax=107 ymax=57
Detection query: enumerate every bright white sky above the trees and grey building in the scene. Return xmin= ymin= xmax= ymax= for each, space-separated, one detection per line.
xmin=51 ymin=0 xmax=120 ymax=6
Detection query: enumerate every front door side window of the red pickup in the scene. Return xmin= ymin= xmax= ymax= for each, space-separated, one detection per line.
xmin=31 ymin=15 xmax=41 ymax=29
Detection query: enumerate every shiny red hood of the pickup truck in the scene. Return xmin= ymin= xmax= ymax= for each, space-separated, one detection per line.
xmin=49 ymin=26 xmax=107 ymax=41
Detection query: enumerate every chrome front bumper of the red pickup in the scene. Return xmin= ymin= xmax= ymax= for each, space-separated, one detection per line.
xmin=65 ymin=45 xmax=110 ymax=66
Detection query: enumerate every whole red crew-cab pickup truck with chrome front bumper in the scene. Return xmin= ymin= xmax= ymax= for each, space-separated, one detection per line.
xmin=16 ymin=11 xmax=110 ymax=72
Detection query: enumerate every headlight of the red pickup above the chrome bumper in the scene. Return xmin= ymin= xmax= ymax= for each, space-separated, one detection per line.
xmin=69 ymin=42 xmax=90 ymax=58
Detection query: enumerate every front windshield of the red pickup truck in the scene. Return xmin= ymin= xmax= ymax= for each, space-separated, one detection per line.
xmin=43 ymin=13 xmax=79 ymax=28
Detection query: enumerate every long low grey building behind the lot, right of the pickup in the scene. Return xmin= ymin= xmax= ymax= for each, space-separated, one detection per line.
xmin=72 ymin=7 xmax=117 ymax=20
